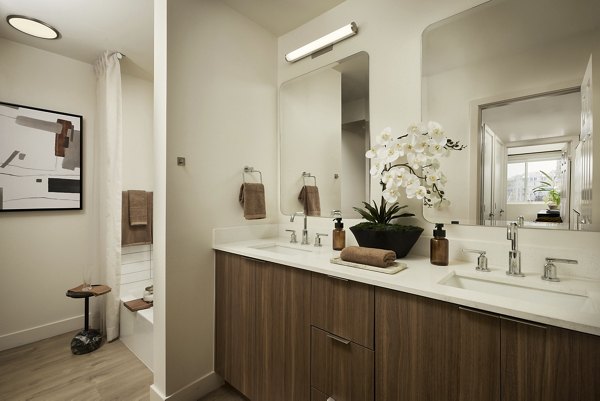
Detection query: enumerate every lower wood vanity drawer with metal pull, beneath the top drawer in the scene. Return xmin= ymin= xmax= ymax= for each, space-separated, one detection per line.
xmin=310 ymin=327 xmax=375 ymax=401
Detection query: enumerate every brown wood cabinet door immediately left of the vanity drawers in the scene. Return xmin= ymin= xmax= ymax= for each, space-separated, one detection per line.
xmin=254 ymin=261 xmax=310 ymax=401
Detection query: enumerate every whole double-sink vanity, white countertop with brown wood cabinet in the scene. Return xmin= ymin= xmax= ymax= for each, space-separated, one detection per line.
xmin=215 ymin=240 xmax=600 ymax=401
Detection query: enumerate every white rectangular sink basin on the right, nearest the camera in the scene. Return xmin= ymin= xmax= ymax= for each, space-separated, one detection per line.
xmin=439 ymin=273 xmax=588 ymax=310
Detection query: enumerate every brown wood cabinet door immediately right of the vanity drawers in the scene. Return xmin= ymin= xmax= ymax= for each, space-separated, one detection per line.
xmin=375 ymin=288 xmax=460 ymax=401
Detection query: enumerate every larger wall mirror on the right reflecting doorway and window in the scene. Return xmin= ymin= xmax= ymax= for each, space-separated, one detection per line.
xmin=422 ymin=0 xmax=600 ymax=231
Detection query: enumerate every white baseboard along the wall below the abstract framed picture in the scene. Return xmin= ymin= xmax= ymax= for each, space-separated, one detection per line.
xmin=0 ymin=315 xmax=83 ymax=351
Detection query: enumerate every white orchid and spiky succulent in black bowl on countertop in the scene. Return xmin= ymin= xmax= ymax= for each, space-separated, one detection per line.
xmin=350 ymin=121 xmax=465 ymax=258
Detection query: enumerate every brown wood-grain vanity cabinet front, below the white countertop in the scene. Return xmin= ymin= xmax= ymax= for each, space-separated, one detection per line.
xmin=215 ymin=251 xmax=600 ymax=401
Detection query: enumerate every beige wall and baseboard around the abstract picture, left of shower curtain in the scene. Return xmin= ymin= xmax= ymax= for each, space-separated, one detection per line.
xmin=0 ymin=39 xmax=96 ymax=349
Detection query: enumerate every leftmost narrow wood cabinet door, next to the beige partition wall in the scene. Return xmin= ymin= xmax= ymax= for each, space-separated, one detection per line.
xmin=215 ymin=252 xmax=255 ymax=399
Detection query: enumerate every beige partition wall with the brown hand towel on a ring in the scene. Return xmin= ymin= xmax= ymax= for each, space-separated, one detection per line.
xmin=162 ymin=0 xmax=278 ymax=396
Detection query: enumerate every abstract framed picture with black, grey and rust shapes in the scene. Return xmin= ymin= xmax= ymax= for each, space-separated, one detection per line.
xmin=0 ymin=102 xmax=83 ymax=212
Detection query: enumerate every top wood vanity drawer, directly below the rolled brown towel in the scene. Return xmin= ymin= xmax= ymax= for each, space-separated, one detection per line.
xmin=311 ymin=273 xmax=375 ymax=349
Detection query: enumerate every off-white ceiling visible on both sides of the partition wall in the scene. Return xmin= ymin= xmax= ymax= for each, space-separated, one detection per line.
xmin=0 ymin=0 xmax=344 ymax=79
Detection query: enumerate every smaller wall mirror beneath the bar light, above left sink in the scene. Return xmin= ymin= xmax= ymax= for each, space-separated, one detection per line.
xmin=279 ymin=52 xmax=370 ymax=218
